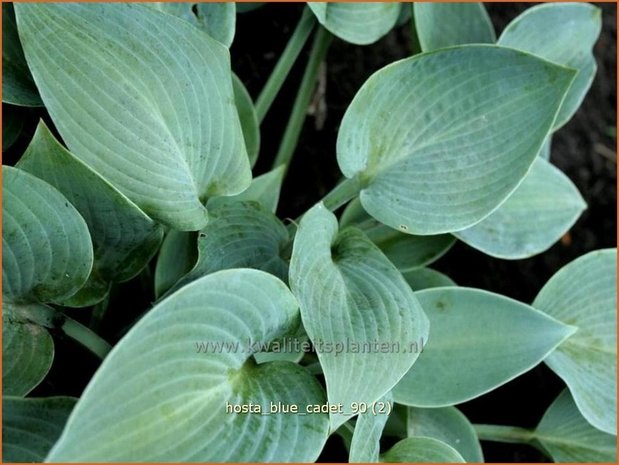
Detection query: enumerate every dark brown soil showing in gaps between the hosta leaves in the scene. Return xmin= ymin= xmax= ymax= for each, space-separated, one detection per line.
xmin=13 ymin=3 xmax=617 ymax=462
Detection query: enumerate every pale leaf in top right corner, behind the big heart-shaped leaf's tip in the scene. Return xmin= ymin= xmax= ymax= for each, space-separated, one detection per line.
xmin=498 ymin=3 xmax=602 ymax=129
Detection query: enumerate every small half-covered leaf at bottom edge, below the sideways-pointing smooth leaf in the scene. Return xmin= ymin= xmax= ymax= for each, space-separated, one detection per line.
xmin=407 ymin=407 xmax=484 ymax=463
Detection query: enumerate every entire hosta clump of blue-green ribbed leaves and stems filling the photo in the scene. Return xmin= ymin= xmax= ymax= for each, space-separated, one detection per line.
xmin=2 ymin=3 xmax=616 ymax=462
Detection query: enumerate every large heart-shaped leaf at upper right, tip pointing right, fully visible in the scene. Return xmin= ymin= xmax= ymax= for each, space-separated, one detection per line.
xmin=337 ymin=45 xmax=574 ymax=235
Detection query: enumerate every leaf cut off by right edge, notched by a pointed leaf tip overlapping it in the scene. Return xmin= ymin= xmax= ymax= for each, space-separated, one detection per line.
xmin=533 ymin=249 xmax=617 ymax=434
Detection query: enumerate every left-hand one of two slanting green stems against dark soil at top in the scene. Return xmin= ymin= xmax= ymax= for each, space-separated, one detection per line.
xmin=255 ymin=6 xmax=316 ymax=123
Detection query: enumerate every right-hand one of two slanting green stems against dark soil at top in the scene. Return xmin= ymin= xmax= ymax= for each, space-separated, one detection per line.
xmin=273 ymin=27 xmax=332 ymax=169
